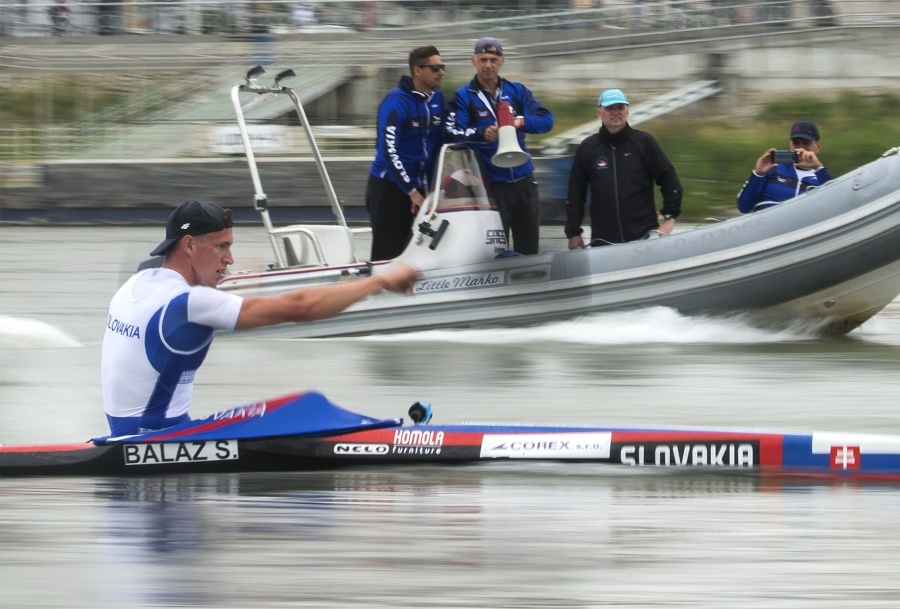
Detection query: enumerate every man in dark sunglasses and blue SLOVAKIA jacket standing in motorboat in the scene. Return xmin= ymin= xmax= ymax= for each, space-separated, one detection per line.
xmin=365 ymin=46 xmax=445 ymax=261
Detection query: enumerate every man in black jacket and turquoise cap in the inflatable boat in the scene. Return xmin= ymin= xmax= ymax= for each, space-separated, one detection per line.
xmin=566 ymin=89 xmax=682 ymax=249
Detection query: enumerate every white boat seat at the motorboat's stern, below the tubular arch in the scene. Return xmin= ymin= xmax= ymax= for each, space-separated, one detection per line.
xmin=272 ymin=224 xmax=359 ymax=266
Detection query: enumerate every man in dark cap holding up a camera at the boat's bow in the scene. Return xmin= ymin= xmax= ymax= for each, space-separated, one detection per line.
xmin=738 ymin=121 xmax=831 ymax=214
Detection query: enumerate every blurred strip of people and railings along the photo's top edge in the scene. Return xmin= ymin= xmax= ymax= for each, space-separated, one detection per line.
xmin=0 ymin=0 xmax=856 ymax=37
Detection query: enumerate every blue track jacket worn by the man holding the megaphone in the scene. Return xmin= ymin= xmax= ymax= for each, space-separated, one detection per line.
xmin=445 ymin=78 xmax=553 ymax=182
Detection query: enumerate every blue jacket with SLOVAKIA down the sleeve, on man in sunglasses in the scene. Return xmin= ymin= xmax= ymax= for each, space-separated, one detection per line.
xmin=371 ymin=76 xmax=445 ymax=194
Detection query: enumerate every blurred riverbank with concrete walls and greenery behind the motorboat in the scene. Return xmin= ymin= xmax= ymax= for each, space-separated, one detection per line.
xmin=0 ymin=0 xmax=900 ymax=223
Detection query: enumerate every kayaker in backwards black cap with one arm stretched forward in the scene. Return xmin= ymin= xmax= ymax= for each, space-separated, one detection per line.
xmin=100 ymin=201 xmax=416 ymax=436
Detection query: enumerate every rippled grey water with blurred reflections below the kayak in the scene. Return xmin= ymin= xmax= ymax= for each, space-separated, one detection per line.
xmin=0 ymin=464 xmax=900 ymax=607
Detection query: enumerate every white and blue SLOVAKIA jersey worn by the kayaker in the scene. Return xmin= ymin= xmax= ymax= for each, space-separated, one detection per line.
xmin=100 ymin=268 xmax=243 ymax=435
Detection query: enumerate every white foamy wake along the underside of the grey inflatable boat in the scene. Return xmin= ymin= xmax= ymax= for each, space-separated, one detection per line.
xmin=362 ymin=307 xmax=822 ymax=345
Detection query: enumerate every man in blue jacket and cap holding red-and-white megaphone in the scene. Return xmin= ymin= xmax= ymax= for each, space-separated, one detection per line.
xmin=445 ymin=37 xmax=553 ymax=254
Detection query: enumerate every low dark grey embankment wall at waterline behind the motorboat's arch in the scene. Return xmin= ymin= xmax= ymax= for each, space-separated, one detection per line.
xmin=0 ymin=159 xmax=371 ymax=223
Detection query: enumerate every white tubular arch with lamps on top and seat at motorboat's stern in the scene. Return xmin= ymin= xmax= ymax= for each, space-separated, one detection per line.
xmin=231 ymin=66 xmax=369 ymax=269
